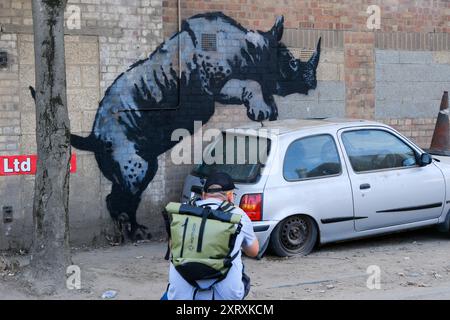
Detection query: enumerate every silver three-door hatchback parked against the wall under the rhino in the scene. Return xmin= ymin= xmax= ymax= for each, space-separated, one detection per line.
xmin=181 ymin=119 xmax=450 ymax=256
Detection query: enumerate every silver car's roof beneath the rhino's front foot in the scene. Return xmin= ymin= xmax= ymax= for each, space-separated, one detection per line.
xmin=225 ymin=118 xmax=381 ymax=135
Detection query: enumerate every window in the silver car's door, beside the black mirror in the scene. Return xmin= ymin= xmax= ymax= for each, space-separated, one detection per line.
xmin=342 ymin=129 xmax=417 ymax=172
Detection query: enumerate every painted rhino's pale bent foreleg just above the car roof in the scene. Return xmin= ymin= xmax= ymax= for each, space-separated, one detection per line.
xmin=219 ymin=79 xmax=278 ymax=121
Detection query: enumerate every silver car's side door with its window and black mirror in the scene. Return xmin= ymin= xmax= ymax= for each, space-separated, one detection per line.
xmin=339 ymin=127 xmax=445 ymax=231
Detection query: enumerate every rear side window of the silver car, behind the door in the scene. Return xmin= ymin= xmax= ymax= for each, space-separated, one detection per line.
xmin=283 ymin=135 xmax=341 ymax=181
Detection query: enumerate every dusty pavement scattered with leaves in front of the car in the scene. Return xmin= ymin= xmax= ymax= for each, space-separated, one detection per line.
xmin=0 ymin=225 xmax=450 ymax=299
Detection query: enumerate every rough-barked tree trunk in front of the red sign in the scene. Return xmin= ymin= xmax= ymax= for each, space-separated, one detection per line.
xmin=30 ymin=0 xmax=71 ymax=293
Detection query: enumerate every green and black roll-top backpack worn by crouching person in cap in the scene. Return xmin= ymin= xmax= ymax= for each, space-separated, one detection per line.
xmin=166 ymin=201 xmax=242 ymax=290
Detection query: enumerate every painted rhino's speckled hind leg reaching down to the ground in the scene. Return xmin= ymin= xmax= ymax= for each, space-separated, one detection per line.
xmin=106 ymin=139 xmax=157 ymax=241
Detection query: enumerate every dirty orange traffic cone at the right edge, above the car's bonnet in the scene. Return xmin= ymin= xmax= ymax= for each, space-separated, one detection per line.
xmin=429 ymin=91 xmax=450 ymax=155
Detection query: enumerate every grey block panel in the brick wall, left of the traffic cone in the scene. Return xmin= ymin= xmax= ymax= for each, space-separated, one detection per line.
xmin=375 ymin=49 xmax=450 ymax=119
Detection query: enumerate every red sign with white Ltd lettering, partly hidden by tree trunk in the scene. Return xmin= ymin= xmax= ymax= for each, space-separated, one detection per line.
xmin=0 ymin=153 xmax=77 ymax=176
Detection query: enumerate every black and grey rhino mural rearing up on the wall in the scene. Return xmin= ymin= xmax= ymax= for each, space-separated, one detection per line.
xmin=71 ymin=12 xmax=320 ymax=240
